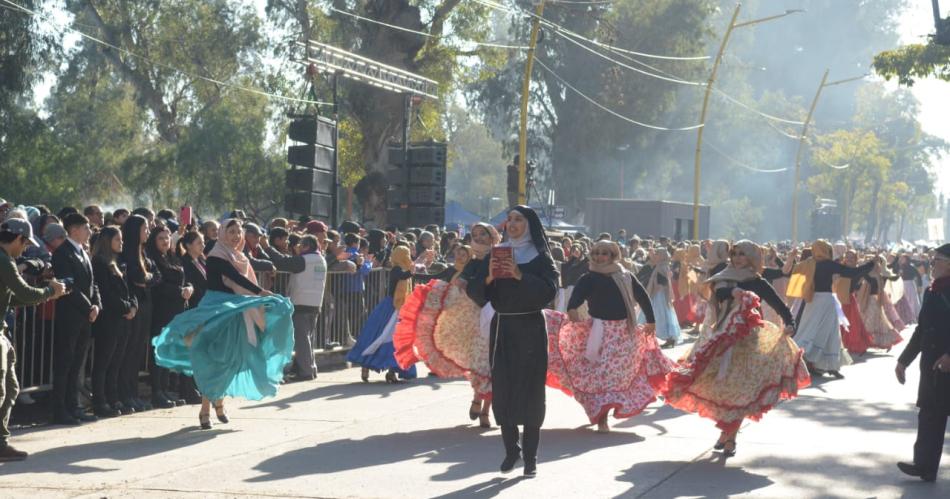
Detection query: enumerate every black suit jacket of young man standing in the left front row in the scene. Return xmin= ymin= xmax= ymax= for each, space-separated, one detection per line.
xmin=53 ymin=241 xmax=102 ymax=324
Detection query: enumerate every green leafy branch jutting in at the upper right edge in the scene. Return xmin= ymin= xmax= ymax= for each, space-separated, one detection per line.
xmin=874 ymin=40 xmax=950 ymax=86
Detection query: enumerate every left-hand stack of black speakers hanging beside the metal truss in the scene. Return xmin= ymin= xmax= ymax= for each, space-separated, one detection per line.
xmin=284 ymin=116 xmax=336 ymax=222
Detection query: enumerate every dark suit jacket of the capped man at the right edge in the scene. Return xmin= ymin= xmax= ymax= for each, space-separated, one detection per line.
xmin=898 ymin=277 xmax=950 ymax=415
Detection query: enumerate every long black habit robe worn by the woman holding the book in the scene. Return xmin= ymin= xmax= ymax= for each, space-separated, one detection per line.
xmin=467 ymin=254 xmax=558 ymax=428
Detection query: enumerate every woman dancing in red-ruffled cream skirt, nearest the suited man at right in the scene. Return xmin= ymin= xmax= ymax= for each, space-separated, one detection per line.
xmin=663 ymin=241 xmax=810 ymax=456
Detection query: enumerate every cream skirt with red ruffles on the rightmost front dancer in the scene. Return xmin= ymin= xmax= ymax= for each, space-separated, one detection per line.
xmin=662 ymin=291 xmax=811 ymax=431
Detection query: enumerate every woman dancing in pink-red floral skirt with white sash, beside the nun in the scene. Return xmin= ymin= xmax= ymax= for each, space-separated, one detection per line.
xmin=548 ymin=241 xmax=673 ymax=433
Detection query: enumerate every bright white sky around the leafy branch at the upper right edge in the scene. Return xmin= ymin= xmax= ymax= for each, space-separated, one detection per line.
xmin=889 ymin=4 xmax=950 ymax=196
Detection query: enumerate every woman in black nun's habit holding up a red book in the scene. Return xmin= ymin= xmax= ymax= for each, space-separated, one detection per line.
xmin=467 ymin=206 xmax=558 ymax=477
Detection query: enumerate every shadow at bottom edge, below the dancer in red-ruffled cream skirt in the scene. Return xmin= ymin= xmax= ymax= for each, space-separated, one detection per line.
xmin=617 ymin=455 xmax=774 ymax=497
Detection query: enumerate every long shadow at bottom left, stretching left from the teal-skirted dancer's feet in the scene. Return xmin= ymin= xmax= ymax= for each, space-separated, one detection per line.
xmin=0 ymin=428 xmax=233 ymax=475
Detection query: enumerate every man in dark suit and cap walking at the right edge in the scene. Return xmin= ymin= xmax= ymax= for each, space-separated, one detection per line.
xmin=895 ymin=244 xmax=950 ymax=482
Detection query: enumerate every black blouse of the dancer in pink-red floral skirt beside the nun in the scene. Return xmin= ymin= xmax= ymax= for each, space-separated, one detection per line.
xmin=567 ymin=272 xmax=655 ymax=324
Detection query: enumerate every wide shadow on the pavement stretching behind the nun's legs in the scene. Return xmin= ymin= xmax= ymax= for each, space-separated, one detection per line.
xmin=248 ymin=426 xmax=644 ymax=488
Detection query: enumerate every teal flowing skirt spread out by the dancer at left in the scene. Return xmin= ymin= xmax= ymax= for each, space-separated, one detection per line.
xmin=152 ymin=291 xmax=294 ymax=400
